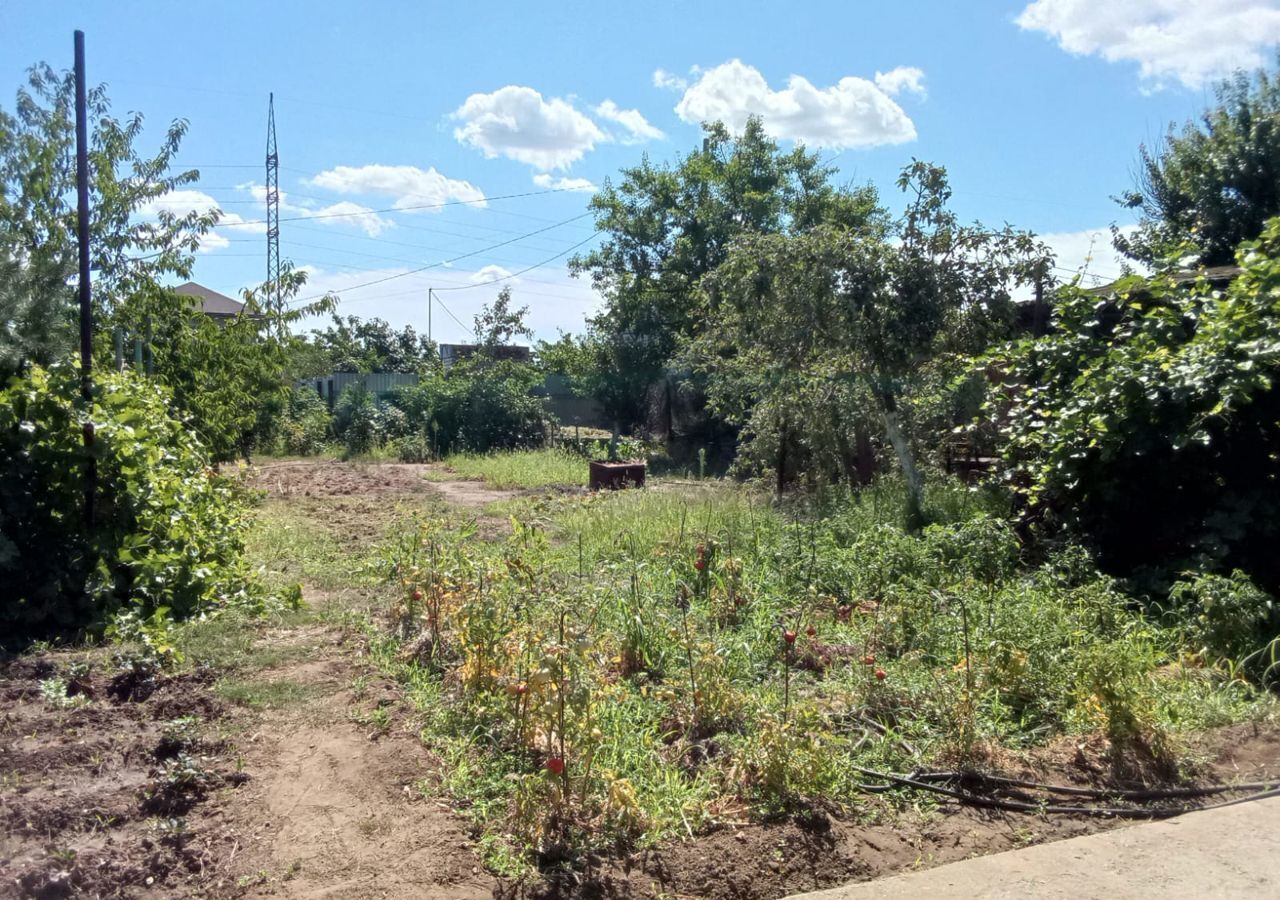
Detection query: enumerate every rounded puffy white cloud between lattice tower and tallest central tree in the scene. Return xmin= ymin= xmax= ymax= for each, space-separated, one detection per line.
xmin=451 ymin=84 xmax=608 ymax=172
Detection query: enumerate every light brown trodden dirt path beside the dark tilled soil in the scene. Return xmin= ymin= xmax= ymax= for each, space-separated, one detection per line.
xmin=222 ymin=629 xmax=493 ymax=900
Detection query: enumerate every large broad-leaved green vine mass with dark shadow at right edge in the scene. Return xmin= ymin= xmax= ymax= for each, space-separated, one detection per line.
xmin=992 ymin=219 xmax=1280 ymax=590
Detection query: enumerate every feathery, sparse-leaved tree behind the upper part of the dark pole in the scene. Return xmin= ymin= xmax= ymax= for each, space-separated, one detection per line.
xmin=0 ymin=64 xmax=218 ymax=374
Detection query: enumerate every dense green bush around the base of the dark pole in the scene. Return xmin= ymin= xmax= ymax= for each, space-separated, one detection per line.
xmin=0 ymin=365 xmax=262 ymax=643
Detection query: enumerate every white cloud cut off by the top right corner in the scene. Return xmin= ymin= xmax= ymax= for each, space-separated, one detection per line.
xmin=1016 ymin=0 xmax=1280 ymax=88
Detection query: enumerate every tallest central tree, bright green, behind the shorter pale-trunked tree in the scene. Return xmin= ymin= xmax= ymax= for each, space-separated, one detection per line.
xmin=570 ymin=118 xmax=881 ymax=442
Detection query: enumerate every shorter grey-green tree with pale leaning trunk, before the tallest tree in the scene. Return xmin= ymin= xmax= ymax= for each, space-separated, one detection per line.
xmin=692 ymin=163 xmax=1043 ymax=522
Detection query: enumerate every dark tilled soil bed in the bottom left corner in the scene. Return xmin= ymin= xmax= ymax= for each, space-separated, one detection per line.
xmin=0 ymin=650 xmax=244 ymax=897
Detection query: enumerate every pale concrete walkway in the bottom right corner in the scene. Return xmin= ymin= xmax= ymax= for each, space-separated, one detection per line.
xmin=792 ymin=798 xmax=1280 ymax=900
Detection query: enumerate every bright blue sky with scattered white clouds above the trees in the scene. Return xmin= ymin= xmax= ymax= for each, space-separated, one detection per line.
xmin=0 ymin=0 xmax=1280 ymax=341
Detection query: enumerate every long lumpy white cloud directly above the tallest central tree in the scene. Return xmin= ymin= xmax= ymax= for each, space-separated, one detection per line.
xmin=676 ymin=59 xmax=915 ymax=149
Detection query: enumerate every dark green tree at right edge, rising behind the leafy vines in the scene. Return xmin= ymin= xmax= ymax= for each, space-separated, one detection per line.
xmin=1116 ymin=60 xmax=1280 ymax=265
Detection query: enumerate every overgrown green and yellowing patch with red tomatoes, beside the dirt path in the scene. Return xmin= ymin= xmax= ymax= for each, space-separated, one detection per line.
xmin=355 ymin=452 xmax=1274 ymax=871
